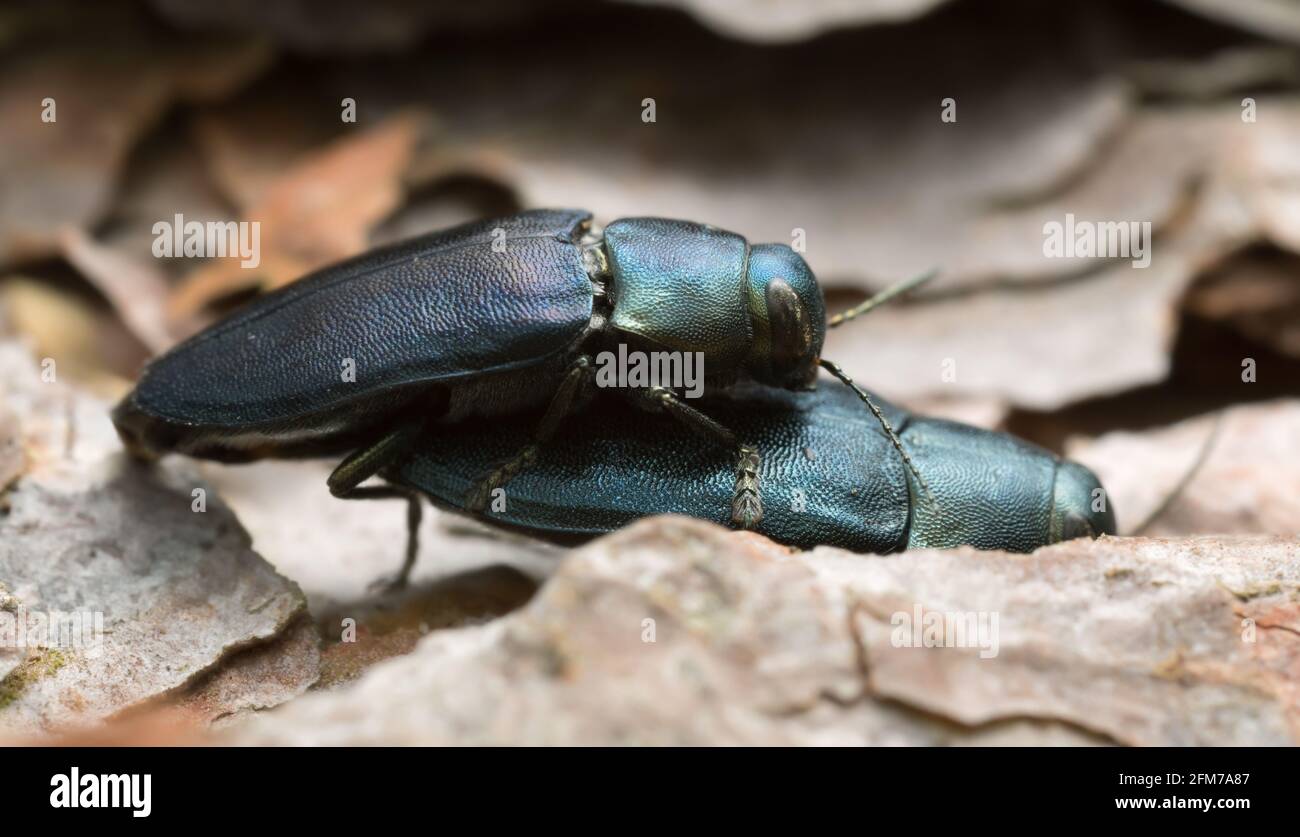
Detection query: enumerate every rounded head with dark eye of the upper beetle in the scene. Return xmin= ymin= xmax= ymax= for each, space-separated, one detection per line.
xmin=746 ymin=244 xmax=826 ymax=390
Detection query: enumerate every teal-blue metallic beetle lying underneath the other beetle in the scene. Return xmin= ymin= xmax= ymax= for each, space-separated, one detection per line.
xmin=385 ymin=387 xmax=1115 ymax=554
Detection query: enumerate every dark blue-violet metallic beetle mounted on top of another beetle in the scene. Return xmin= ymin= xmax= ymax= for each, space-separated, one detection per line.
xmin=113 ymin=209 xmax=928 ymax=582
